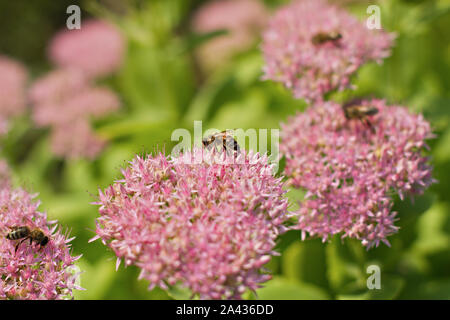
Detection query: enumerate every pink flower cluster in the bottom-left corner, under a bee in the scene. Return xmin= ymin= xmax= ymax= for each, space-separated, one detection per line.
xmin=0 ymin=183 xmax=82 ymax=300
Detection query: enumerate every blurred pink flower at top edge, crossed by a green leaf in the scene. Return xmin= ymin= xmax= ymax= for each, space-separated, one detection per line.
xmin=193 ymin=0 xmax=268 ymax=68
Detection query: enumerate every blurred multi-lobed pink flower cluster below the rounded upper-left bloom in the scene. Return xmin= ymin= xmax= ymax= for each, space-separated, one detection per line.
xmin=29 ymin=69 xmax=120 ymax=158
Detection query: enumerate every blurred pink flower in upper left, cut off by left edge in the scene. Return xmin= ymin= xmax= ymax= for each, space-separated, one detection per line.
xmin=0 ymin=56 xmax=28 ymax=134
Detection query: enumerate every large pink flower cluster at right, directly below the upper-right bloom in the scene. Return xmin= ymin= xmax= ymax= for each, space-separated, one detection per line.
xmin=280 ymin=100 xmax=434 ymax=248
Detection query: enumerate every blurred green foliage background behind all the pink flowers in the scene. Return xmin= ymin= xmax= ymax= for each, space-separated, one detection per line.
xmin=0 ymin=0 xmax=450 ymax=299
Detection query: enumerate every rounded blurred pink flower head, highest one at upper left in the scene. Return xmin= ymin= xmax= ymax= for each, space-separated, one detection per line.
xmin=49 ymin=20 xmax=125 ymax=78
